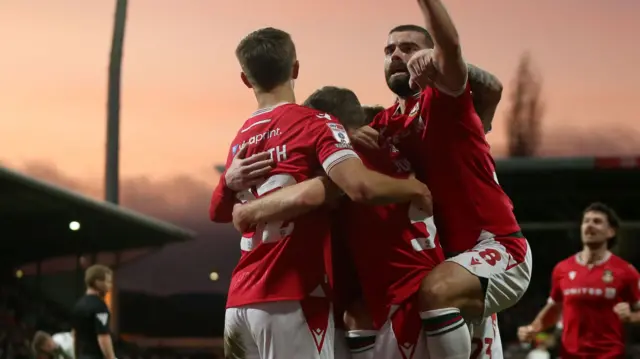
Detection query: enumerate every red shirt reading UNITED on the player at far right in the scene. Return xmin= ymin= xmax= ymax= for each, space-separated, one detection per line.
xmin=549 ymin=253 xmax=640 ymax=359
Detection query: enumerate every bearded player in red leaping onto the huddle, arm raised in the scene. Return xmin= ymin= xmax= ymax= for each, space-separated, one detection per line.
xmin=376 ymin=0 xmax=531 ymax=358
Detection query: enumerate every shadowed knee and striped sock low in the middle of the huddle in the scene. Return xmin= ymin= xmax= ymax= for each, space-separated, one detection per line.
xmin=344 ymin=299 xmax=378 ymax=359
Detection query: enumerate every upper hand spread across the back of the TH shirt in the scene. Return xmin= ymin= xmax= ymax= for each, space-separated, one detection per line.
xmin=224 ymin=146 xmax=275 ymax=192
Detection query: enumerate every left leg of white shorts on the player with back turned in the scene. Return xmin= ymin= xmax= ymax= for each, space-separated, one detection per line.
xmin=224 ymin=308 xmax=260 ymax=359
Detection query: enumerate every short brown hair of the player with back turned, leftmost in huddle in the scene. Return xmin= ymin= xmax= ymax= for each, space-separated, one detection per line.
xmin=236 ymin=27 xmax=296 ymax=91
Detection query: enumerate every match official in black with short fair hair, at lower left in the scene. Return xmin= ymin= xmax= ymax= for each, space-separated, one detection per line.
xmin=72 ymin=264 xmax=116 ymax=359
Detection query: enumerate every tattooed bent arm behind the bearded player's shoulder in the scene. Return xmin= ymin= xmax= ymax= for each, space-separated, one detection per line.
xmin=467 ymin=64 xmax=502 ymax=133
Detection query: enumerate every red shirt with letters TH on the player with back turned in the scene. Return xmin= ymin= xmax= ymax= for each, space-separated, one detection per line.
xmin=227 ymin=104 xmax=358 ymax=307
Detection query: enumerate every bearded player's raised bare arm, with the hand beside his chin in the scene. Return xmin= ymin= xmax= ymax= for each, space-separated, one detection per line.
xmin=408 ymin=0 xmax=468 ymax=96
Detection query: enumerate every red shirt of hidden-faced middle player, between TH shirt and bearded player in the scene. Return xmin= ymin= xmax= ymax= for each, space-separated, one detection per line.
xmin=341 ymin=144 xmax=444 ymax=327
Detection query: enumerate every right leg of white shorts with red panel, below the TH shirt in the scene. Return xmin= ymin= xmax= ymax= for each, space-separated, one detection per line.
xmin=245 ymin=297 xmax=335 ymax=359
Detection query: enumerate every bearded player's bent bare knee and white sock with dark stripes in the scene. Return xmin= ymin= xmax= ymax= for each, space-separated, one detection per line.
xmin=418 ymin=262 xmax=484 ymax=359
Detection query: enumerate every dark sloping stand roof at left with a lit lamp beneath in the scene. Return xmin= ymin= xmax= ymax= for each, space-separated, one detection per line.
xmin=0 ymin=167 xmax=194 ymax=265
